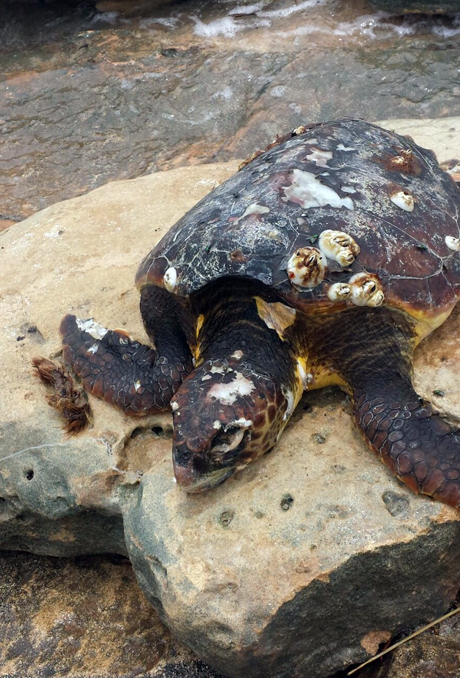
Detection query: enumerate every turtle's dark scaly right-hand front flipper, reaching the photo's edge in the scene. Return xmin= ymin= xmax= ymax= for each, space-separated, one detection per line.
xmin=312 ymin=308 xmax=460 ymax=507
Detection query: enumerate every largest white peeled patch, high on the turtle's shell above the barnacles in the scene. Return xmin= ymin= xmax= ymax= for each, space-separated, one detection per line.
xmin=282 ymin=169 xmax=354 ymax=210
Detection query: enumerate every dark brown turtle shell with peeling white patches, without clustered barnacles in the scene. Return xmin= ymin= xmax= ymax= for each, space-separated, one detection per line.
xmin=136 ymin=120 xmax=460 ymax=317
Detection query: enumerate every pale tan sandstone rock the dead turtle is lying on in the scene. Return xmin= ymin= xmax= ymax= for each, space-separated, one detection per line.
xmin=0 ymin=121 xmax=460 ymax=678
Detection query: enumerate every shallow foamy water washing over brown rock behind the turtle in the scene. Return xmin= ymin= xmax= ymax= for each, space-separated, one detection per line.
xmin=0 ymin=0 xmax=460 ymax=225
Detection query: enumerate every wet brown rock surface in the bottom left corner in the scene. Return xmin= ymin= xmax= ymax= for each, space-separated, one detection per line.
xmin=0 ymin=552 xmax=223 ymax=678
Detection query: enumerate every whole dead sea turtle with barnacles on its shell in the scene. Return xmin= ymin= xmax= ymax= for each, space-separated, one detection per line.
xmin=48 ymin=120 xmax=460 ymax=506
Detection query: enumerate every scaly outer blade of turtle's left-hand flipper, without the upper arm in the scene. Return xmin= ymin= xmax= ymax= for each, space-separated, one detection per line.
xmin=60 ymin=315 xmax=191 ymax=416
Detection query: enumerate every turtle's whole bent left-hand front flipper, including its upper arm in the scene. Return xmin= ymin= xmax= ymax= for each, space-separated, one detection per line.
xmin=60 ymin=288 xmax=193 ymax=416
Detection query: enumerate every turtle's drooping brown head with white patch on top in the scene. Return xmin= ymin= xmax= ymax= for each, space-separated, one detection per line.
xmin=171 ymin=359 xmax=289 ymax=493
